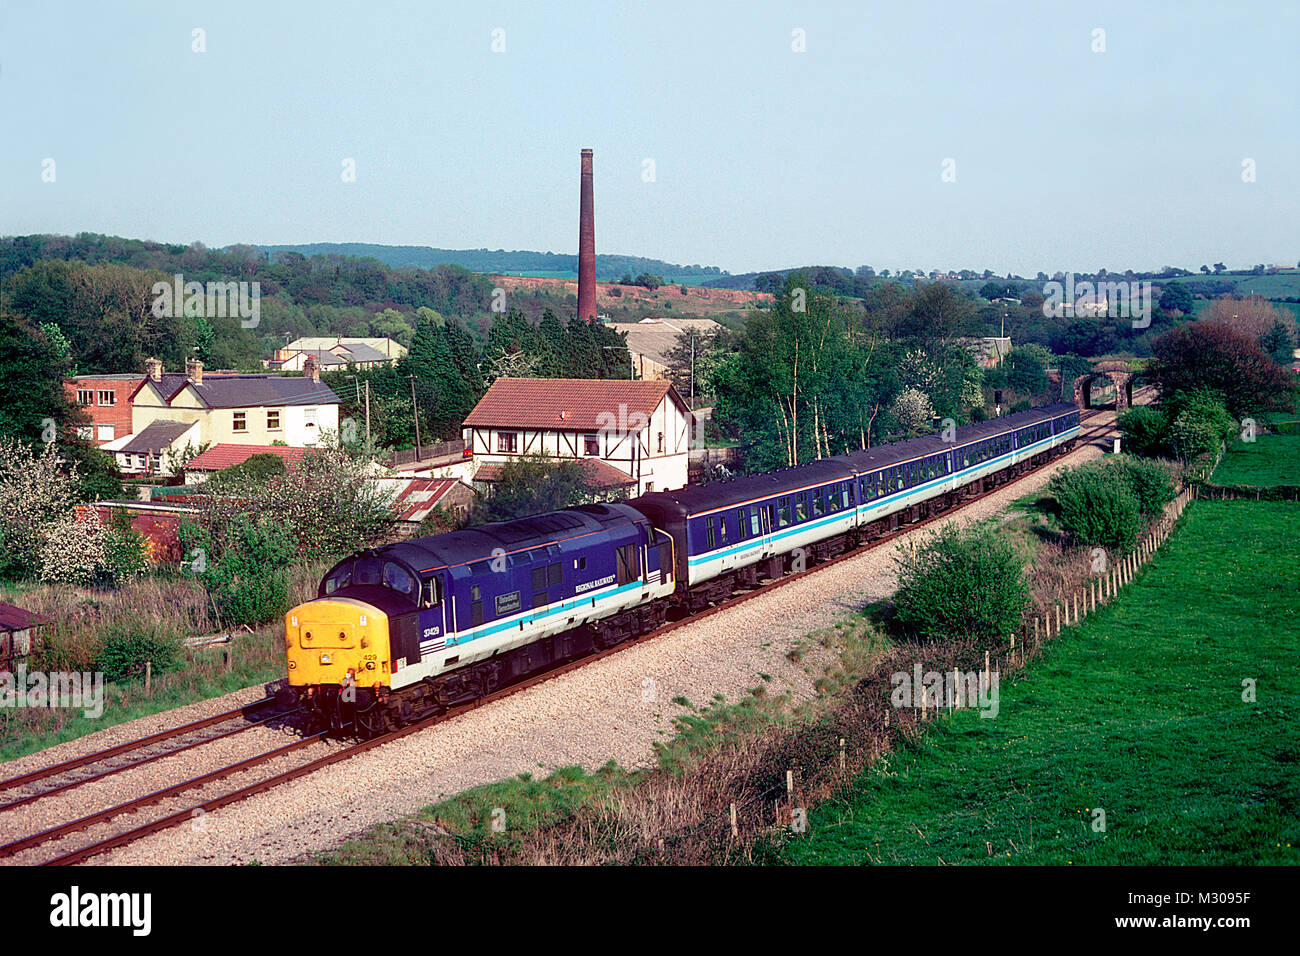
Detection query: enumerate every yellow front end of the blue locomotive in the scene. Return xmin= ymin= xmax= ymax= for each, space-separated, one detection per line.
xmin=292 ymin=597 xmax=391 ymax=730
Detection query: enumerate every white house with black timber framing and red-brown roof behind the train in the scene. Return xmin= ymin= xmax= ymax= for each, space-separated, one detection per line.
xmin=464 ymin=378 xmax=694 ymax=494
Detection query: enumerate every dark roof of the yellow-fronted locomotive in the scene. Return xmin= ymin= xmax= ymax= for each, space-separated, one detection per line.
xmin=352 ymin=503 xmax=644 ymax=571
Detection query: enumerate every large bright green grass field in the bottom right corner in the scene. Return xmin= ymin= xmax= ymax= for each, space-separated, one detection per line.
xmin=784 ymin=501 xmax=1300 ymax=865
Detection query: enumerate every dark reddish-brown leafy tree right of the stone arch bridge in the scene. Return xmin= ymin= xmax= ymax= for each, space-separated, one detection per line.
xmin=1148 ymin=319 xmax=1295 ymax=419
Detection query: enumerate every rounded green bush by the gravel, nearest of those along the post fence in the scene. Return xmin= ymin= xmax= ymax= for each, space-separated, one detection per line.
xmin=894 ymin=524 xmax=1030 ymax=643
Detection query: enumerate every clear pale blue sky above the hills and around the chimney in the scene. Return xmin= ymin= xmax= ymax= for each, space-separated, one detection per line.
xmin=0 ymin=0 xmax=1300 ymax=276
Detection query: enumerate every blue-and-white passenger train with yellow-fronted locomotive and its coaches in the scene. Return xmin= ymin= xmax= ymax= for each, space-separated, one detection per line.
xmin=285 ymin=403 xmax=1080 ymax=737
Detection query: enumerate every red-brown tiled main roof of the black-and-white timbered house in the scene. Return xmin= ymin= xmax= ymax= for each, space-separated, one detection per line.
xmin=465 ymin=378 xmax=686 ymax=431
